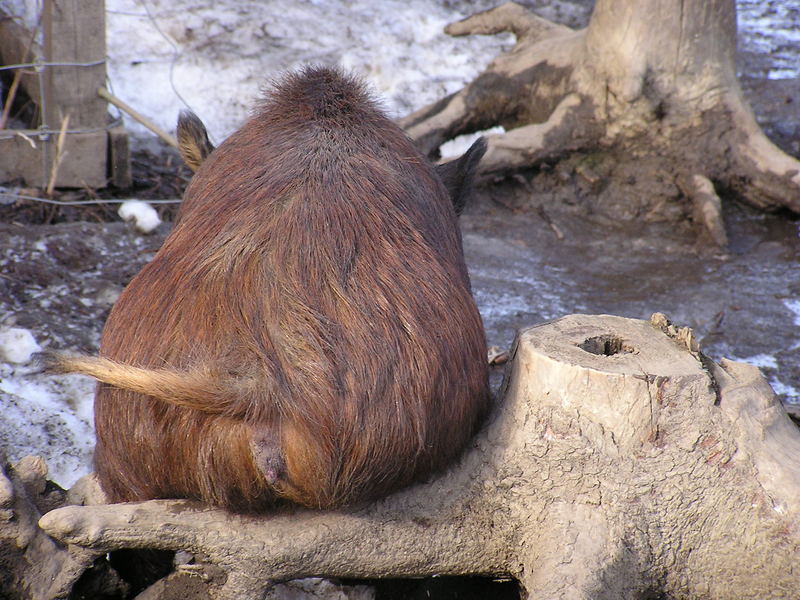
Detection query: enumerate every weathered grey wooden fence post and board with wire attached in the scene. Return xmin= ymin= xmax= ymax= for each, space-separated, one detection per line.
xmin=0 ymin=0 xmax=130 ymax=188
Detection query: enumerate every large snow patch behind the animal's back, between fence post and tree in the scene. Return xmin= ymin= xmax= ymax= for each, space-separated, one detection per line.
xmin=106 ymin=0 xmax=513 ymax=143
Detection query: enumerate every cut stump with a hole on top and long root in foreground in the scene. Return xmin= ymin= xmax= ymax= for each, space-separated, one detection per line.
xmin=7 ymin=315 xmax=800 ymax=600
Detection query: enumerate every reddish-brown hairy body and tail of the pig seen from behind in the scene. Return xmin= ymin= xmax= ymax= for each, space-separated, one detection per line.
xmin=54 ymin=68 xmax=489 ymax=510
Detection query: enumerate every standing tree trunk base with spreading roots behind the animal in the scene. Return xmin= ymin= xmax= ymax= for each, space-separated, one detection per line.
xmin=401 ymin=0 xmax=800 ymax=243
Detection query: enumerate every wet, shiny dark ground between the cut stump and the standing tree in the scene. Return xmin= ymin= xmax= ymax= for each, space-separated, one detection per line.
xmin=462 ymin=199 xmax=800 ymax=403
